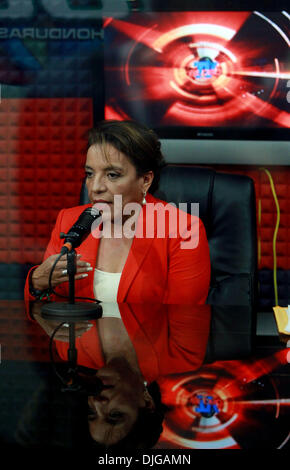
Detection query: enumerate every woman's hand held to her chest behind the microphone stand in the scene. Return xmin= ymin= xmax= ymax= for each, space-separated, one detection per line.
xmin=31 ymin=255 xmax=93 ymax=290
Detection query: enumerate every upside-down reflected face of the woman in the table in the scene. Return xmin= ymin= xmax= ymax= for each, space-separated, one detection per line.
xmin=88 ymin=367 xmax=153 ymax=446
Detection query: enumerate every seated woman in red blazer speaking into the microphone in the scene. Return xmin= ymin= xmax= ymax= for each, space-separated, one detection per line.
xmin=25 ymin=121 xmax=210 ymax=304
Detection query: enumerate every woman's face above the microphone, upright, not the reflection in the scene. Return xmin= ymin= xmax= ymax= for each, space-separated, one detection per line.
xmin=85 ymin=144 xmax=153 ymax=220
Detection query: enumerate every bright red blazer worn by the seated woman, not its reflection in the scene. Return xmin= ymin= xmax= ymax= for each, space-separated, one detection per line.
xmin=25 ymin=194 xmax=210 ymax=305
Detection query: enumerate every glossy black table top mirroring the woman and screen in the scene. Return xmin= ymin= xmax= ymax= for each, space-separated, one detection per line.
xmin=0 ymin=301 xmax=290 ymax=458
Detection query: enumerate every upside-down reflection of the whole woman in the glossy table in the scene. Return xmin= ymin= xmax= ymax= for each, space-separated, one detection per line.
xmin=36 ymin=304 xmax=209 ymax=448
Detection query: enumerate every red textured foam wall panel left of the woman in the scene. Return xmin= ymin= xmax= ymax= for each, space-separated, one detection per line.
xmin=0 ymin=98 xmax=93 ymax=264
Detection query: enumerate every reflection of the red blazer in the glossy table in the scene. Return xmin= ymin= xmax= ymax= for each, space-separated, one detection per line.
xmin=56 ymin=303 xmax=210 ymax=382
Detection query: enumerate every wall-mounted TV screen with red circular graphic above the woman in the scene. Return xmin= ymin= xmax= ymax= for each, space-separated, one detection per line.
xmin=104 ymin=10 xmax=290 ymax=140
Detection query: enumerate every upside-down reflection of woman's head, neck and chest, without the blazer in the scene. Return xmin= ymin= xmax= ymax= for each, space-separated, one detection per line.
xmin=86 ymin=317 xmax=159 ymax=447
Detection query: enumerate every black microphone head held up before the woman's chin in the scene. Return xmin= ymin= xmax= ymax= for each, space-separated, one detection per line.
xmin=60 ymin=207 xmax=101 ymax=255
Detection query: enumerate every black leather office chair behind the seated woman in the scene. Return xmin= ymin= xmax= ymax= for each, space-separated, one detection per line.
xmin=80 ymin=165 xmax=257 ymax=362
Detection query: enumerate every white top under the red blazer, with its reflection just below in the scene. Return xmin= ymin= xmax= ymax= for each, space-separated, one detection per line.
xmin=94 ymin=269 xmax=122 ymax=318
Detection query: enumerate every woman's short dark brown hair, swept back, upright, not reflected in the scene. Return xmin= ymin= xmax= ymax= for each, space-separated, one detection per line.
xmin=88 ymin=120 xmax=166 ymax=193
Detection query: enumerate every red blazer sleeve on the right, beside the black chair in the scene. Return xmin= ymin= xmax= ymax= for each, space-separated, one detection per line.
xmin=163 ymin=216 xmax=210 ymax=304
